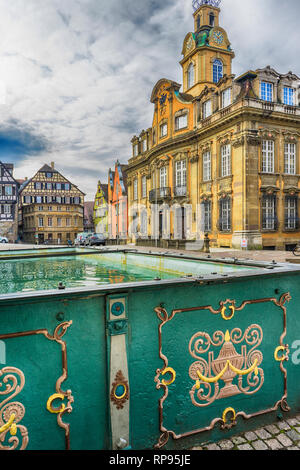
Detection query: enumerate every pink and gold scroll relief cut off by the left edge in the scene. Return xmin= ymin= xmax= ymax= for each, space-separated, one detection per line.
xmin=0 ymin=367 xmax=29 ymax=450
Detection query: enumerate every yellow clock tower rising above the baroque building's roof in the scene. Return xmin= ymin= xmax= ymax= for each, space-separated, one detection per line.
xmin=180 ymin=0 xmax=234 ymax=96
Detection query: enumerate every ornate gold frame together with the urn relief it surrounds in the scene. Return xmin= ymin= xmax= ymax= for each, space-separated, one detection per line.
xmin=154 ymin=292 xmax=291 ymax=449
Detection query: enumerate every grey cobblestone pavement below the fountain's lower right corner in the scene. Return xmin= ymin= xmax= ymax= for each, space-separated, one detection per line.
xmin=191 ymin=414 xmax=300 ymax=451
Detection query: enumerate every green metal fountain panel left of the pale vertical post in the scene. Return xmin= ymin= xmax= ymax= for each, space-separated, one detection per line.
xmin=1 ymin=296 xmax=109 ymax=450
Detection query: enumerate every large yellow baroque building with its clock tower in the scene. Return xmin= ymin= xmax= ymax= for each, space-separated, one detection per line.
xmin=127 ymin=0 xmax=300 ymax=249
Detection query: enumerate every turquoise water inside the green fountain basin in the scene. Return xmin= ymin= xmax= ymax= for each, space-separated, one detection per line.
xmin=0 ymin=253 xmax=255 ymax=295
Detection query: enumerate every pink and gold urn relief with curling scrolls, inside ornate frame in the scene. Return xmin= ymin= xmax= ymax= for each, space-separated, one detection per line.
xmin=189 ymin=325 xmax=264 ymax=407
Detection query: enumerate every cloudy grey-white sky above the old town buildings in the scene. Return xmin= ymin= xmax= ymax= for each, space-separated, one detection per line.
xmin=0 ymin=0 xmax=300 ymax=200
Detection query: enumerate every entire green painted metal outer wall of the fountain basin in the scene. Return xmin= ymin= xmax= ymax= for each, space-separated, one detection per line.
xmin=0 ymin=250 xmax=300 ymax=450
